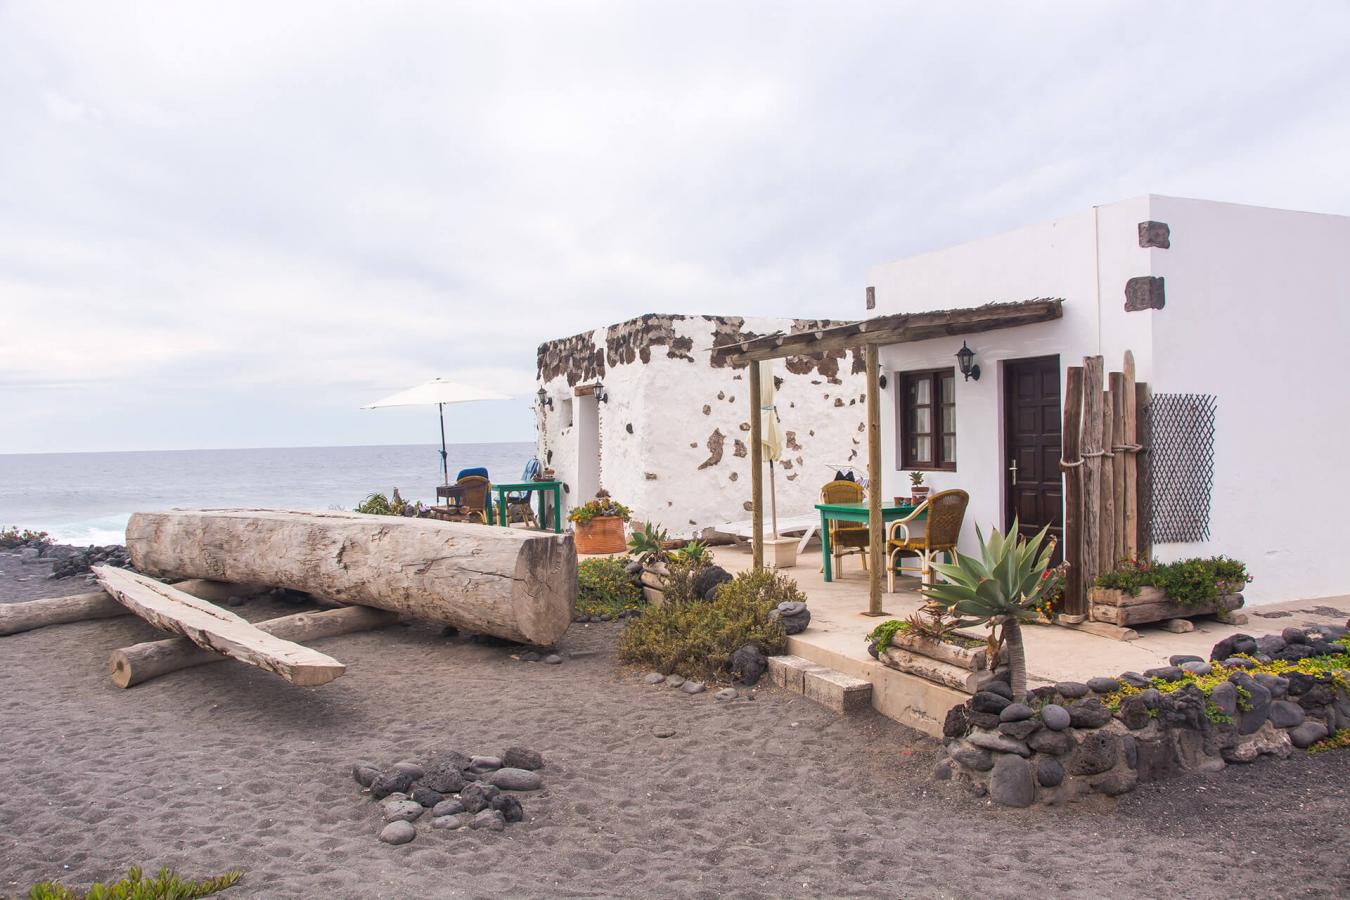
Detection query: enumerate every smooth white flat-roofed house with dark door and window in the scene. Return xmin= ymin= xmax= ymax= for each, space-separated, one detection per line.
xmin=841 ymin=196 xmax=1350 ymax=604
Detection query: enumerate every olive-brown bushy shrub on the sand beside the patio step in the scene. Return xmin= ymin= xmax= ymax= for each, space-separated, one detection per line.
xmin=618 ymin=564 xmax=806 ymax=679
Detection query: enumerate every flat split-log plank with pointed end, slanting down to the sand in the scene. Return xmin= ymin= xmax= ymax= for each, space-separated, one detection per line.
xmin=93 ymin=565 xmax=347 ymax=687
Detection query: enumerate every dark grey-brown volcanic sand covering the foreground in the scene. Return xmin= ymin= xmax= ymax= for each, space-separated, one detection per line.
xmin=0 ymin=556 xmax=1350 ymax=899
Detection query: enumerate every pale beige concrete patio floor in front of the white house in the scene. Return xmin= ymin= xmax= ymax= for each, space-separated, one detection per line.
xmin=714 ymin=546 xmax=1350 ymax=734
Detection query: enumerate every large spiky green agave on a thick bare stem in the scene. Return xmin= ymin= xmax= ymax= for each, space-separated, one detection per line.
xmin=919 ymin=519 xmax=1054 ymax=700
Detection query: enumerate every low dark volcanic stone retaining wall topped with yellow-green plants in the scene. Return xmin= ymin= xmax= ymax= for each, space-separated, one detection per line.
xmin=934 ymin=627 xmax=1350 ymax=807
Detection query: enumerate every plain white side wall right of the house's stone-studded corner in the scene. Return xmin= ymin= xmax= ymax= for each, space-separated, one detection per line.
xmin=1146 ymin=197 xmax=1350 ymax=602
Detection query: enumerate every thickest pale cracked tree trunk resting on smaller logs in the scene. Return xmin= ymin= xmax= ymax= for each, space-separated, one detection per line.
xmin=127 ymin=509 xmax=576 ymax=646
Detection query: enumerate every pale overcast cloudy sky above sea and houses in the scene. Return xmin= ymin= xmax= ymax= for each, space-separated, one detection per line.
xmin=0 ymin=0 xmax=1350 ymax=452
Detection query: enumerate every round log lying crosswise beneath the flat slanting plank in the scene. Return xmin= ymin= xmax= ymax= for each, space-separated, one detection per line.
xmin=108 ymin=606 xmax=398 ymax=688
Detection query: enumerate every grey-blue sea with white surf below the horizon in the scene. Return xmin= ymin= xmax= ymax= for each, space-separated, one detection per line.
xmin=0 ymin=443 xmax=535 ymax=546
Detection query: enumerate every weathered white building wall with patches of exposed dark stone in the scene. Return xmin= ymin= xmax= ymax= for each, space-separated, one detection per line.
xmin=539 ymin=314 xmax=867 ymax=537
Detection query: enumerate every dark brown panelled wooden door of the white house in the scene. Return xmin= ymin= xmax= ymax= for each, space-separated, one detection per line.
xmin=1003 ymin=356 xmax=1064 ymax=563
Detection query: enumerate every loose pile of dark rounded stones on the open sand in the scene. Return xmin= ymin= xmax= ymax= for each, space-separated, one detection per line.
xmin=351 ymin=748 xmax=544 ymax=845
